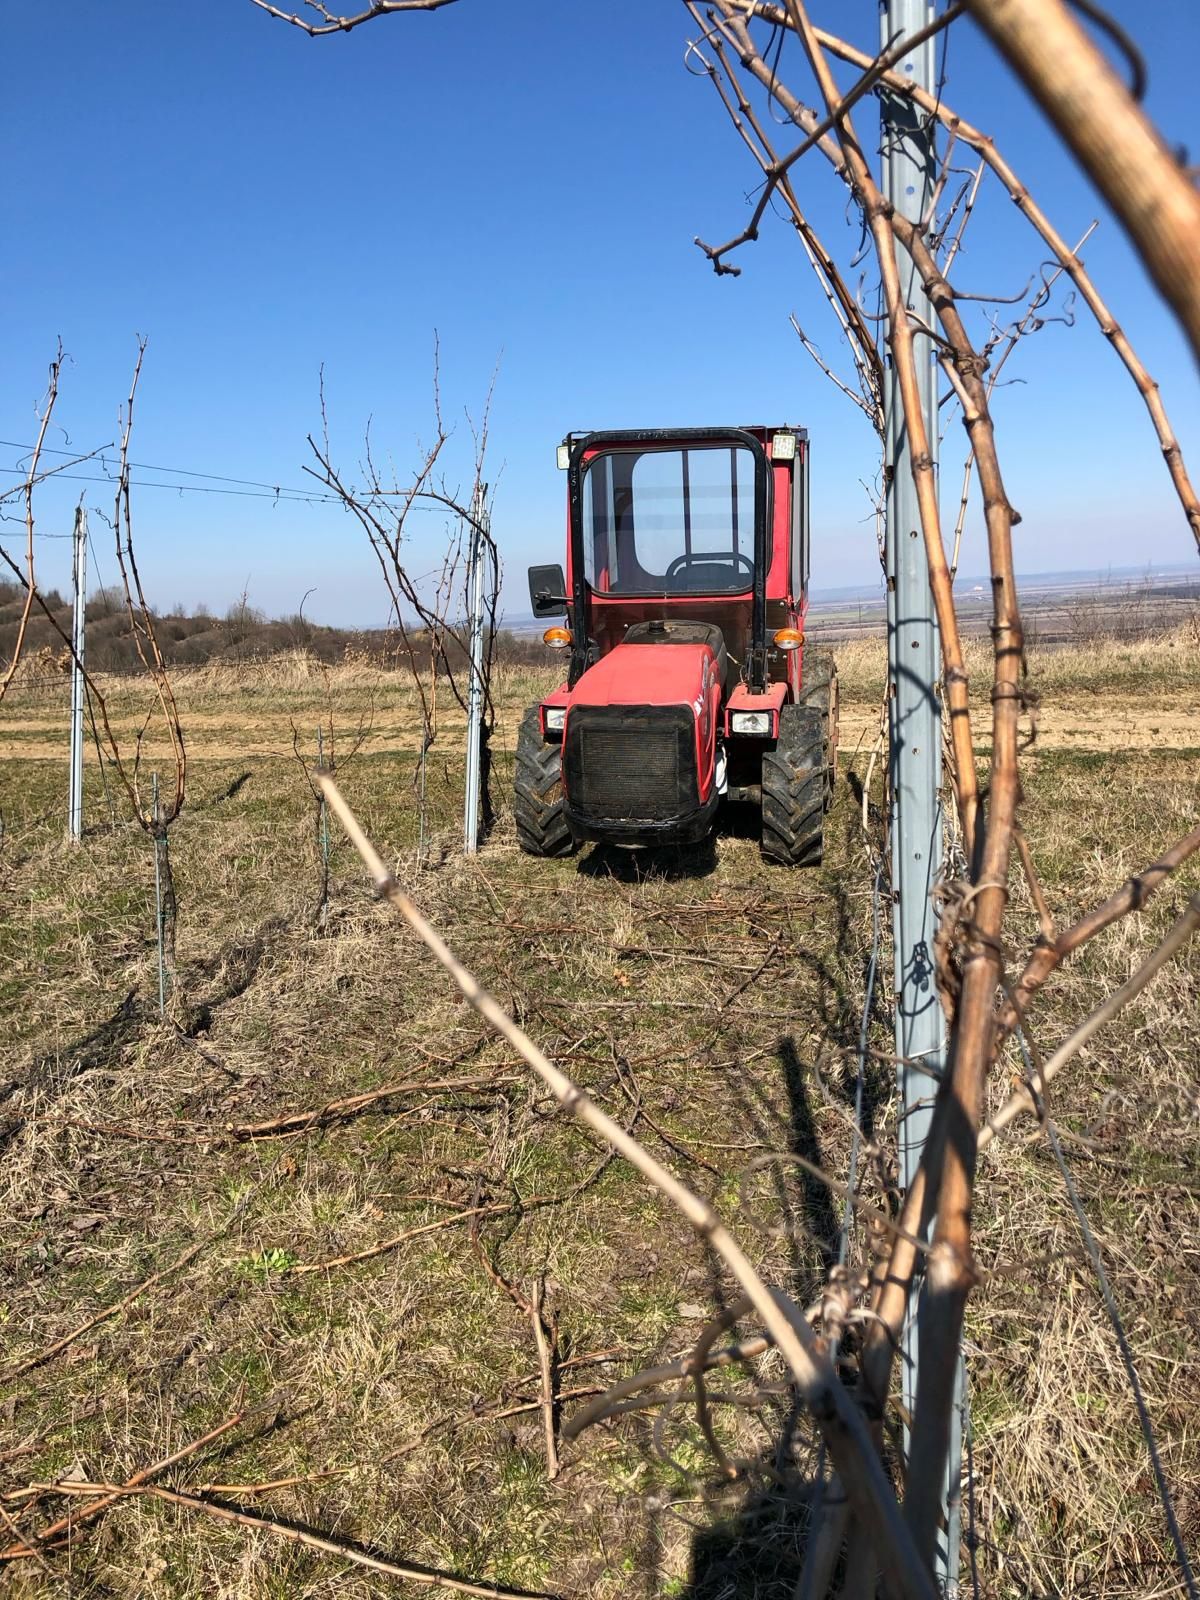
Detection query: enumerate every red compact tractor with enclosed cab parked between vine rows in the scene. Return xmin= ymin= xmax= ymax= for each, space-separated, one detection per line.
xmin=514 ymin=427 xmax=837 ymax=866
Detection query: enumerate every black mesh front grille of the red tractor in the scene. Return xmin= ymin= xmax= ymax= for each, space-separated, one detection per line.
xmin=563 ymin=706 xmax=698 ymax=829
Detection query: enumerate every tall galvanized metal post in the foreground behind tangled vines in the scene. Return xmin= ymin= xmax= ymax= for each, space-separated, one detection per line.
xmin=882 ymin=0 xmax=962 ymax=1595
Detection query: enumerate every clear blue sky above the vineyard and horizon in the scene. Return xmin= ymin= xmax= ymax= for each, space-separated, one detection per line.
xmin=0 ymin=0 xmax=1200 ymax=624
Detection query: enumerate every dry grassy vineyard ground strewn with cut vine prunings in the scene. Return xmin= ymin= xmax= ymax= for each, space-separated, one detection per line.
xmin=0 ymin=635 xmax=1200 ymax=1600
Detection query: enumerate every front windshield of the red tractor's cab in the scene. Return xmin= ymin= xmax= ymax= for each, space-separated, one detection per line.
xmin=582 ymin=443 xmax=754 ymax=595
